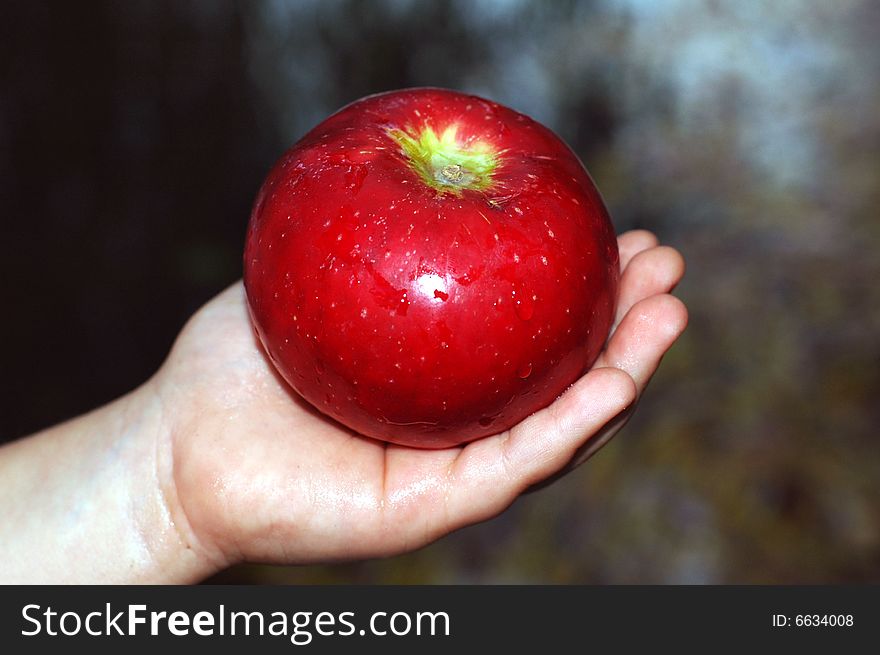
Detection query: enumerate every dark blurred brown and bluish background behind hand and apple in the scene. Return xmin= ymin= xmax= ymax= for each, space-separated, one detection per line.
xmin=0 ymin=0 xmax=880 ymax=583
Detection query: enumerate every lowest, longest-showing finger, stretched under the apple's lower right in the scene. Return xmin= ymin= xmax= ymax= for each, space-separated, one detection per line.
xmin=446 ymin=368 xmax=636 ymax=529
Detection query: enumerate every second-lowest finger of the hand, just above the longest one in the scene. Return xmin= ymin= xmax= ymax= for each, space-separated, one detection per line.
xmin=596 ymin=294 xmax=688 ymax=393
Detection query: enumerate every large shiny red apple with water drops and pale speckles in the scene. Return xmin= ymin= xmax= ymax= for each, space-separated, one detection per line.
xmin=244 ymin=88 xmax=620 ymax=448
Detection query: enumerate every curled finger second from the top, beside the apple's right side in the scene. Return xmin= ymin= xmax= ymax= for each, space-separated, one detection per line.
xmin=614 ymin=246 xmax=685 ymax=326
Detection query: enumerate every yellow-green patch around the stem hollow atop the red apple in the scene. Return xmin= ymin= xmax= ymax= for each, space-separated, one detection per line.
xmin=388 ymin=125 xmax=498 ymax=195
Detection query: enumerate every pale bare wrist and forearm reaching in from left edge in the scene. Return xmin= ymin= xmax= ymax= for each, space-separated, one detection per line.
xmin=0 ymin=382 xmax=219 ymax=584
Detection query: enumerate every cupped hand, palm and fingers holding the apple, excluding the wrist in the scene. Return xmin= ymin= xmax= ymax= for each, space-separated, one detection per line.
xmin=151 ymin=233 xmax=686 ymax=563
